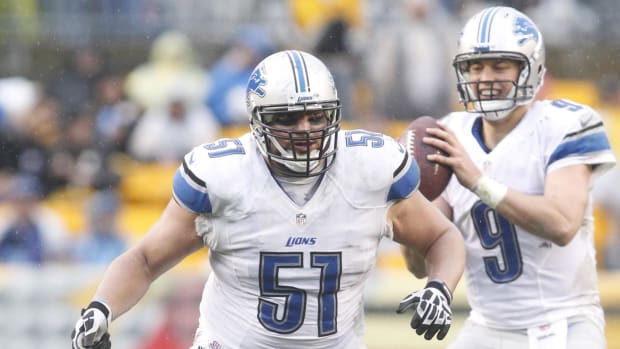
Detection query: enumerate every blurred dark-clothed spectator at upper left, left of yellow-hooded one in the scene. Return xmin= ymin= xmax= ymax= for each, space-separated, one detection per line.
xmin=47 ymin=47 xmax=103 ymax=115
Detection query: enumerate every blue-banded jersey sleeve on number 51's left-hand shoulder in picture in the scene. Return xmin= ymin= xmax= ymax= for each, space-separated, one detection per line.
xmin=172 ymin=146 xmax=211 ymax=214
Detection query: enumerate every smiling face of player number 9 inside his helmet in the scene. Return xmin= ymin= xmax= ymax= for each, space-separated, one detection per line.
xmin=468 ymin=59 xmax=520 ymax=100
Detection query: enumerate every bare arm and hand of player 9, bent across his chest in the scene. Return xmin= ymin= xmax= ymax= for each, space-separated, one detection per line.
xmin=427 ymin=121 xmax=592 ymax=246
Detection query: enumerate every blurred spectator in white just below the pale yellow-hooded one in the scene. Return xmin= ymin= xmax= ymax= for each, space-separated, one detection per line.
xmin=129 ymin=95 xmax=220 ymax=162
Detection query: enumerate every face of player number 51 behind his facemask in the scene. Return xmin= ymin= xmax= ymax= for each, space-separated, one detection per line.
xmin=268 ymin=111 xmax=329 ymax=154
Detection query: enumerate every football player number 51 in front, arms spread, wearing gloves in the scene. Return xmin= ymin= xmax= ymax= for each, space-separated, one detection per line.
xmin=72 ymin=51 xmax=465 ymax=349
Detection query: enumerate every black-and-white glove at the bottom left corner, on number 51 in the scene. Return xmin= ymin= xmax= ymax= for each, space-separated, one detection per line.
xmin=71 ymin=301 xmax=112 ymax=349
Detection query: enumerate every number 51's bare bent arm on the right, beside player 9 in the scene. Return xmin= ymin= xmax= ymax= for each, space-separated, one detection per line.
xmin=388 ymin=192 xmax=465 ymax=291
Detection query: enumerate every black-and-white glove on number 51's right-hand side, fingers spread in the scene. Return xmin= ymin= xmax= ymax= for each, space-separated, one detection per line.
xmin=396 ymin=280 xmax=452 ymax=340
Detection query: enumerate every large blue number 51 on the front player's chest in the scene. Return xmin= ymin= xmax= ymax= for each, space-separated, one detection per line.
xmin=258 ymin=252 xmax=342 ymax=337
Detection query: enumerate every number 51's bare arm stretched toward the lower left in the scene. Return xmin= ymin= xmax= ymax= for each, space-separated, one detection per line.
xmin=94 ymin=200 xmax=203 ymax=318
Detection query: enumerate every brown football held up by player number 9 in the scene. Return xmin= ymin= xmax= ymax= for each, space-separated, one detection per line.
xmin=399 ymin=116 xmax=452 ymax=200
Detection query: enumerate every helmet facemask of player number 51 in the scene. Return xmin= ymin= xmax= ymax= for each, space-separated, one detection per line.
xmin=250 ymin=101 xmax=341 ymax=177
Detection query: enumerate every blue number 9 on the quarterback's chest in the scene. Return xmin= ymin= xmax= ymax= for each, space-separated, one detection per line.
xmin=471 ymin=201 xmax=523 ymax=284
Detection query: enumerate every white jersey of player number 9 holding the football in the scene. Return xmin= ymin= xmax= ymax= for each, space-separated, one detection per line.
xmin=442 ymin=100 xmax=615 ymax=329
